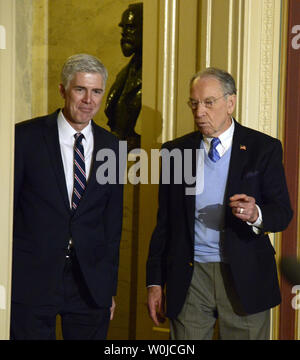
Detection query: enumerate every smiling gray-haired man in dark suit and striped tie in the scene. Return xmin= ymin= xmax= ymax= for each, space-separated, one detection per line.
xmin=11 ymin=54 xmax=123 ymax=339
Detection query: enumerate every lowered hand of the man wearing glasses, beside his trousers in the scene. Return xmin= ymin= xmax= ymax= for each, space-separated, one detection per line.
xmin=148 ymin=286 xmax=166 ymax=326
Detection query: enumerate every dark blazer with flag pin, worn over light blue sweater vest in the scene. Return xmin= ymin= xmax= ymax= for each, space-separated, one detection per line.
xmin=147 ymin=122 xmax=292 ymax=318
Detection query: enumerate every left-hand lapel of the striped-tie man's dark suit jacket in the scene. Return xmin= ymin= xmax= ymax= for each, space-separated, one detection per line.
xmin=44 ymin=110 xmax=71 ymax=211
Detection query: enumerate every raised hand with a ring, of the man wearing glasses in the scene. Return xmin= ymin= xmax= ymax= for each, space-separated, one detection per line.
xmin=229 ymin=194 xmax=259 ymax=223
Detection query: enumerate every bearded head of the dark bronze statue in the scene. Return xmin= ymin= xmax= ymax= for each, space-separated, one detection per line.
xmin=119 ymin=3 xmax=143 ymax=57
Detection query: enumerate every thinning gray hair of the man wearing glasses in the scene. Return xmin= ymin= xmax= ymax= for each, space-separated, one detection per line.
xmin=190 ymin=67 xmax=237 ymax=95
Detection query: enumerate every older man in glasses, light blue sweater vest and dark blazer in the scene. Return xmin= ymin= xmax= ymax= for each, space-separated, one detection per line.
xmin=147 ymin=68 xmax=292 ymax=340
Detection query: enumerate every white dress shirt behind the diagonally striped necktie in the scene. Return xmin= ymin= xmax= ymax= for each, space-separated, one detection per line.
xmin=57 ymin=111 xmax=94 ymax=208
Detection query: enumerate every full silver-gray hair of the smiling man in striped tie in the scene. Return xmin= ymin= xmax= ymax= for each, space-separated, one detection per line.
xmin=61 ymin=54 xmax=108 ymax=89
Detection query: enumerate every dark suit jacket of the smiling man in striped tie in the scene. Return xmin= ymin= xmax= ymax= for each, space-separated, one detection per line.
xmin=12 ymin=110 xmax=123 ymax=307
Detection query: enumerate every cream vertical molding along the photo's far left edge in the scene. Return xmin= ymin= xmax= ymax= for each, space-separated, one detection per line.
xmin=0 ymin=0 xmax=15 ymax=340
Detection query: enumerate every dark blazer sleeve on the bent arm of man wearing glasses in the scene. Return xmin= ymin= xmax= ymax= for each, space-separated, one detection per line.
xmin=260 ymin=141 xmax=293 ymax=232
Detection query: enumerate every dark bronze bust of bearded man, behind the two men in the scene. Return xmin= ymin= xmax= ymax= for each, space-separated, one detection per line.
xmin=105 ymin=3 xmax=143 ymax=151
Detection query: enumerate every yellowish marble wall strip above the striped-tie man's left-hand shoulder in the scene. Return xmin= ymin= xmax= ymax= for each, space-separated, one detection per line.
xmin=15 ymin=0 xmax=48 ymax=122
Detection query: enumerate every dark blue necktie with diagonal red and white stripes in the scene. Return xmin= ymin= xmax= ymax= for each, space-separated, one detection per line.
xmin=72 ymin=133 xmax=86 ymax=211
